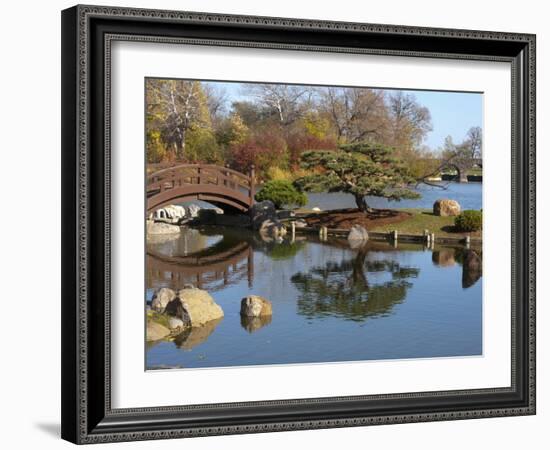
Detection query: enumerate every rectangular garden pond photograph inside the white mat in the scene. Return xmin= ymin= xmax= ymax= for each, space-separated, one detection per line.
xmin=144 ymin=78 xmax=483 ymax=370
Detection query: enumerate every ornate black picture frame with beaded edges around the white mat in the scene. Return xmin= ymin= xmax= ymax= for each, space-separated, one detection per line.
xmin=62 ymin=6 xmax=535 ymax=444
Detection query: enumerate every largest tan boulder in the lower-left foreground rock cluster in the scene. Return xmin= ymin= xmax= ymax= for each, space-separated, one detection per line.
xmin=166 ymin=288 xmax=227 ymax=327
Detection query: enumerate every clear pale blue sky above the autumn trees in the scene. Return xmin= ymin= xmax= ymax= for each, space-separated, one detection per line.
xmin=204 ymin=82 xmax=483 ymax=150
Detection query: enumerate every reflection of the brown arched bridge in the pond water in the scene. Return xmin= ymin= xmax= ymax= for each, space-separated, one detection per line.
xmin=146 ymin=241 xmax=254 ymax=291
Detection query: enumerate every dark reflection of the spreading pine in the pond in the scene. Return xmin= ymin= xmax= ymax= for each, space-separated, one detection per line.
xmin=291 ymin=248 xmax=419 ymax=321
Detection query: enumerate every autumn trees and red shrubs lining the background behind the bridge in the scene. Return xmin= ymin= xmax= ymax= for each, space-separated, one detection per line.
xmin=146 ymin=79 xmax=440 ymax=180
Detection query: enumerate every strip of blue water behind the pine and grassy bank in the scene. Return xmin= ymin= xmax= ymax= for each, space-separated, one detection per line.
xmin=306 ymin=182 xmax=483 ymax=210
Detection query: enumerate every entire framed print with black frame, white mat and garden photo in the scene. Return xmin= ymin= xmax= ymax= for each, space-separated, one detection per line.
xmin=62 ymin=6 xmax=535 ymax=443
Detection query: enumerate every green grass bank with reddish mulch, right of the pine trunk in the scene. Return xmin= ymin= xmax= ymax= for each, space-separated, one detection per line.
xmin=371 ymin=209 xmax=481 ymax=241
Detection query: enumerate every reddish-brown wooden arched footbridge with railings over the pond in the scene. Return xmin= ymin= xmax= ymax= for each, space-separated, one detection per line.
xmin=146 ymin=164 xmax=255 ymax=214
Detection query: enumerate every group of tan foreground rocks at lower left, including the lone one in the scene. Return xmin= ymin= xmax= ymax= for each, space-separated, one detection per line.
xmin=147 ymin=284 xmax=273 ymax=342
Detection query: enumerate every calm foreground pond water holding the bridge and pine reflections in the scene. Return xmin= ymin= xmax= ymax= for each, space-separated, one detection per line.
xmin=146 ymin=227 xmax=482 ymax=369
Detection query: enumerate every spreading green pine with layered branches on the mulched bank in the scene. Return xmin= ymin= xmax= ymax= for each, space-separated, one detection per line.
xmin=295 ymin=142 xmax=420 ymax=213
